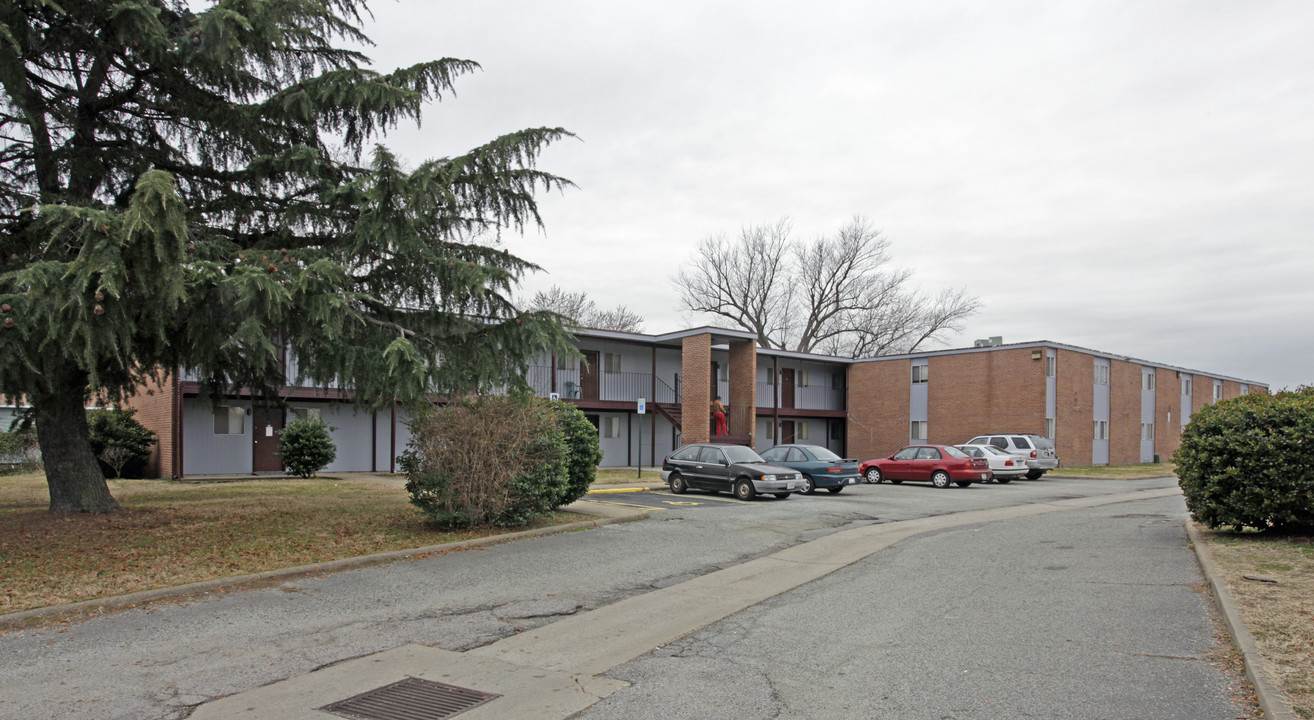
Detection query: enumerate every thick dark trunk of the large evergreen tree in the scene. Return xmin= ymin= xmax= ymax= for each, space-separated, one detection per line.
xmin=32 ymin=382 xmax=118 ymax=512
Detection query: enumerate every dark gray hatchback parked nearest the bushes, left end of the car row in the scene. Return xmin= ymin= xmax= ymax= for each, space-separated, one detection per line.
xmin=661 ymin=444 xmax=803 ymax=501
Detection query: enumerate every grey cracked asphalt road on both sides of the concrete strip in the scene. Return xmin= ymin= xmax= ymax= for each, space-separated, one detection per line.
xmin=0 ymin=480 xmax=1238 ymax=719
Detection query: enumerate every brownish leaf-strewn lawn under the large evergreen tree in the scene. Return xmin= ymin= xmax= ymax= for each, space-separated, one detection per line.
xmin=0 ymin=473 xmax=586 ymax=614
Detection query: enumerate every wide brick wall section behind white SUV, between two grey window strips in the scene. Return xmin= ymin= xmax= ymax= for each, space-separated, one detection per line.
xmin=926 ymin=348 xmax=1045 ymax=445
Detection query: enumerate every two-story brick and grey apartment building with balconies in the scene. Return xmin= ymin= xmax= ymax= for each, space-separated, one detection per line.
xmin=123 ymin=327 xmax=1267 ymax=477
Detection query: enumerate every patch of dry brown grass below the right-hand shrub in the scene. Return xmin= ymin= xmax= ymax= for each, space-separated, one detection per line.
xmin=1200 ymin=527 xmax=1314 ymax=719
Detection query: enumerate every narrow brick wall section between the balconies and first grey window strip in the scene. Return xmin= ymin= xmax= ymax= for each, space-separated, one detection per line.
xmin=845 ymin=360 xmax=911 ymax=460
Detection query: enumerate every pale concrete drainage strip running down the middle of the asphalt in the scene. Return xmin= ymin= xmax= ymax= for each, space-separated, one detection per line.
xmin=192 ymin=487 xmax=1219 ymax=720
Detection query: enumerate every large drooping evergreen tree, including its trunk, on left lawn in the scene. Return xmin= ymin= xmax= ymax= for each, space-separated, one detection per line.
xmin=0 ymin=0 xmax=569 ymax=512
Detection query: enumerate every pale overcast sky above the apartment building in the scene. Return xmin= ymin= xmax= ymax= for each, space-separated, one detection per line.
xmin=354 ymin=0 xmax=1314 ymax=389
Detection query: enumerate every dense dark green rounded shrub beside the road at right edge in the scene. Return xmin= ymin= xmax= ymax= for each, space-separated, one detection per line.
xmin=1173 ymin=388 xmax=1314 ymax=532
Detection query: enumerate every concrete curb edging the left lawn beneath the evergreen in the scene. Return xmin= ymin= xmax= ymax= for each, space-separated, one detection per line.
xmin=0 ymin=503 xmax=650 ymax=632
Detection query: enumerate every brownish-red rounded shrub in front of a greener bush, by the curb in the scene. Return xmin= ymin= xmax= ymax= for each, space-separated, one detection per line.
xmin=401 ymin=395 xmax=575 ymax=528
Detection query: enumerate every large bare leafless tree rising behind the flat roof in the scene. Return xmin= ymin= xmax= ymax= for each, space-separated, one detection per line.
xmin=674 ymin=217 xmax=980 ymax=357
